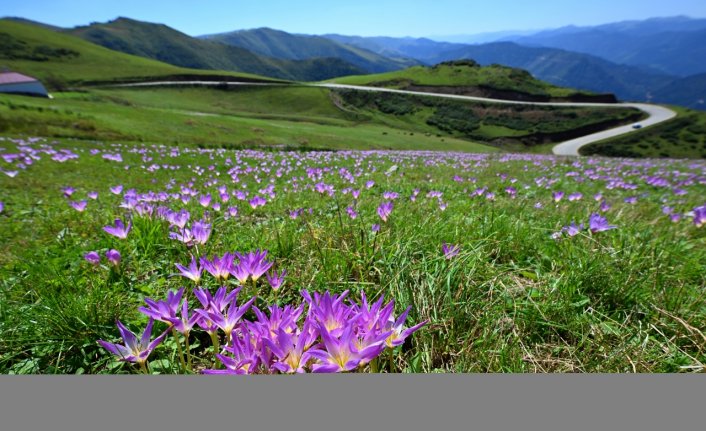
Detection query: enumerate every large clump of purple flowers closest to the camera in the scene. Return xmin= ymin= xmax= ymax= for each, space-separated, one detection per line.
xmin=99 ymin=250 xmax=428 ymax=374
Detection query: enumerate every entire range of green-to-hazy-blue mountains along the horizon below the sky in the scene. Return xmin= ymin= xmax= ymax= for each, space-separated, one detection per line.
xmin=4 ymin=17 xmax=706 ymax=109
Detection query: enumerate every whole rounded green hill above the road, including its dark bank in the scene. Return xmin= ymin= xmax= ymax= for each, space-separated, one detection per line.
xmin=332 ymin=60 xmax=608 ymax=101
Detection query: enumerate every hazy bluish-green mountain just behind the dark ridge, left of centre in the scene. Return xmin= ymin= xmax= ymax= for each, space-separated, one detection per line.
xmin=201 ymin=28 xmax=419 ymax=73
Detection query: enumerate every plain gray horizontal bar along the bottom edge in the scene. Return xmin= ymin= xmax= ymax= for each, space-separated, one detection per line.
xmin=0 ymin=374 xmax=706 ymax=431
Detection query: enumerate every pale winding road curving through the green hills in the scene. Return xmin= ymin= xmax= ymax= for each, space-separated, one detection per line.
xmin=111 ymin=81 xmax=677 ymax=156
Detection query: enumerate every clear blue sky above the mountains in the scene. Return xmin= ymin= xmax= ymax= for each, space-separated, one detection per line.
xmin=0 ymin=0 xmax=706 ymax=37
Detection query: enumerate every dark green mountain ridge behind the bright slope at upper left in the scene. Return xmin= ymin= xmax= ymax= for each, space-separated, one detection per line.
xmin=67 ymin=18 xmax=364 ymax=81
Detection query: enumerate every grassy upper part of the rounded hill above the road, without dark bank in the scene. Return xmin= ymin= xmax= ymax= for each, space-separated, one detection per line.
xmin=334 ymin=60 xmax=588 ymax=97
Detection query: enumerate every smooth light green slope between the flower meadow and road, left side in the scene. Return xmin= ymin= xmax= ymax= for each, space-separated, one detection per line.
xmin=0 ymin=88 xmax=497 ymax=152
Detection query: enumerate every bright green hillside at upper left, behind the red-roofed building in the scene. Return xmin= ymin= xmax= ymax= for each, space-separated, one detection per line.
xmin=0 ymin=20 xmax=272 ymax=83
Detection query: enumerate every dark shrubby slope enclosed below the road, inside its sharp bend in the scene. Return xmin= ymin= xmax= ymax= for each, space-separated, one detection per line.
xmin=336 ymin=90 xmax=643 ymax=152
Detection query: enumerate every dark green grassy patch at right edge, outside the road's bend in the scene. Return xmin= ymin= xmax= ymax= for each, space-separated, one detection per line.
xmin=581 ymin=106 xmax=706 ymax=159
